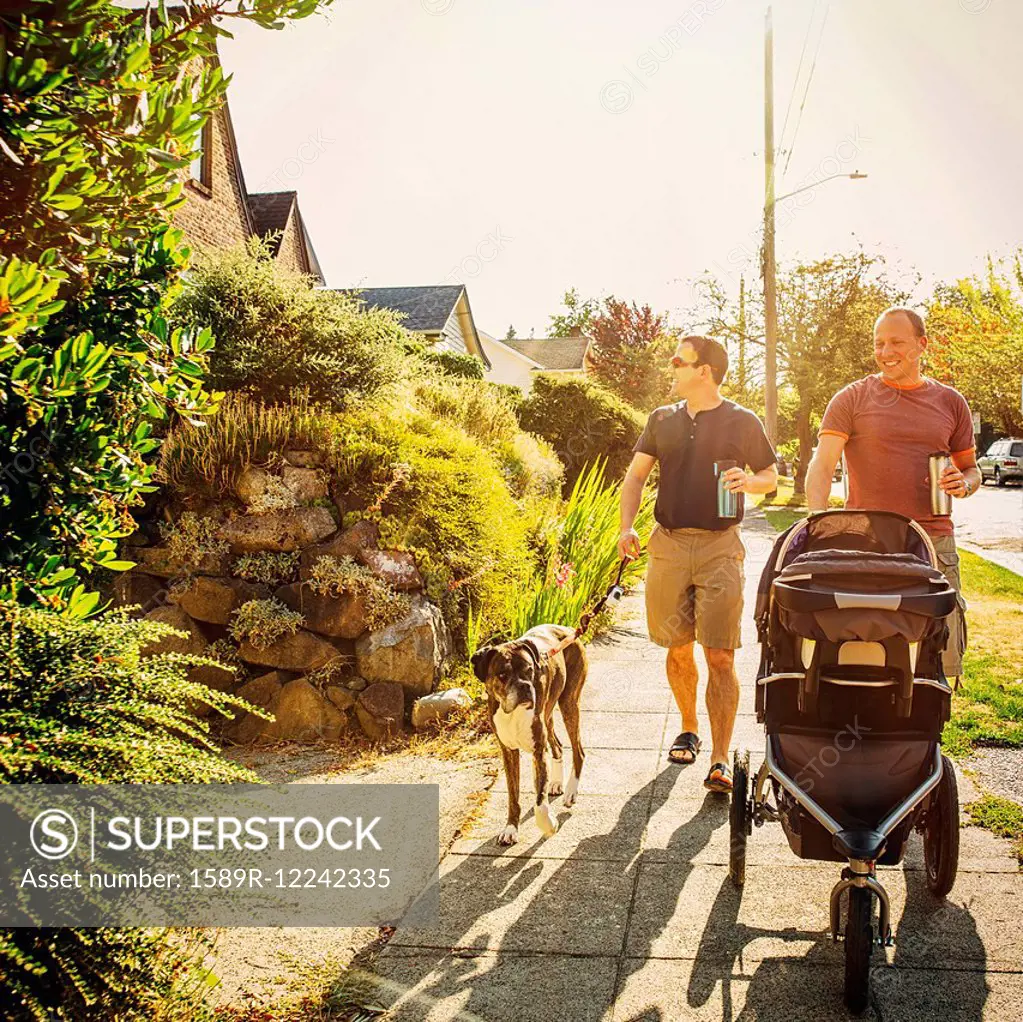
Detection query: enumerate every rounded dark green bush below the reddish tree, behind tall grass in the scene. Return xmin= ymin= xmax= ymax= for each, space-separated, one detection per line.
xmin=519 ymin=373 xmax=646 ymax=489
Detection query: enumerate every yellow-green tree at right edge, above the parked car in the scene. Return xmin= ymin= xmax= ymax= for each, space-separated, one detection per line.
xmin=927 ymin=254 xmax=1023 ymax=436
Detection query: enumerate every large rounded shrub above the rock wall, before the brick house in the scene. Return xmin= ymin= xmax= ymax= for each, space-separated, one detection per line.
xmin=173 ymin=240 xmax=408 ymax=408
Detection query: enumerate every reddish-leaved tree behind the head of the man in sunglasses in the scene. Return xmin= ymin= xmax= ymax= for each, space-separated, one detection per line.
xmin=586 ymin=298 xmax=677 ymax=410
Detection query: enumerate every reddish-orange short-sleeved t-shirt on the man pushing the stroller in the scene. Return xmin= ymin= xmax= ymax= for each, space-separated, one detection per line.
xmin=820 ymin=375 xmax=974 ymax=536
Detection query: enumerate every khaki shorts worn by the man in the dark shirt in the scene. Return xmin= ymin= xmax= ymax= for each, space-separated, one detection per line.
xmin=647 ymin=525 xmax=746 ymax=650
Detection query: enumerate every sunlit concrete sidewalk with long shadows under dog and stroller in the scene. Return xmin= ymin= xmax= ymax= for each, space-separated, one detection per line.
xmin=375 ymin=516 xmax=1023 ymax=1022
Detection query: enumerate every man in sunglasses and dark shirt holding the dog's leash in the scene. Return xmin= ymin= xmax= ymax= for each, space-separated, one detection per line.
xmin=618 ymin=337 xmax=777 ymax=792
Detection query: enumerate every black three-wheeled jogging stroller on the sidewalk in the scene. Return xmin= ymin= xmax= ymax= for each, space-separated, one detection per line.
xmin=729 ymin=510 xmax=959 ymax=1012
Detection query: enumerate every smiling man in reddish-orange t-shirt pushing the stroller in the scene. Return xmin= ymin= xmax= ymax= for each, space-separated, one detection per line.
xmin=806 ymin=307 xmax=981 ymax=678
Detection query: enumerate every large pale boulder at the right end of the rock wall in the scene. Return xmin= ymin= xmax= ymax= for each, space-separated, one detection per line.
xmin=355 ymin=598 xmax=448 ymax=696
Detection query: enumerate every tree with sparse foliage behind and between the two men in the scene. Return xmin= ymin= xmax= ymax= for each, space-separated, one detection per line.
xmin=777 ymin=252 xmax=908 ymax=494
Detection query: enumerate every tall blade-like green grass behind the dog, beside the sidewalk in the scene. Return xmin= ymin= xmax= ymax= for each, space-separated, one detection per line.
xmin=506 ymin=459 xmax=654 ymax=635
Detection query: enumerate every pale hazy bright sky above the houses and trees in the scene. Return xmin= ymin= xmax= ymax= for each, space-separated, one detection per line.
xmin=221 ymin=0 xmax=1023 ymax=337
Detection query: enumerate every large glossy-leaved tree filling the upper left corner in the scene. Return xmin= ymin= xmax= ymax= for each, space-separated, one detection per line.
xmin=0 ymin=0 xmax=317 ymax=612
